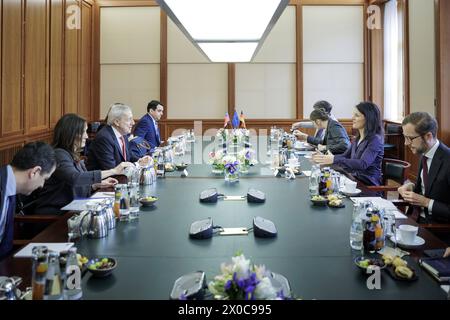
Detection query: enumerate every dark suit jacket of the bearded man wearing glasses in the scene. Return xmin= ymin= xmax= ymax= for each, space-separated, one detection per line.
xmin=414 ymin=141 xmax=450 ymax=223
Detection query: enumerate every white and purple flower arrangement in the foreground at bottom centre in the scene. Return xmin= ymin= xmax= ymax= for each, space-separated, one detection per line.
xmin=208 ymin=253 xmax=289 ymax=300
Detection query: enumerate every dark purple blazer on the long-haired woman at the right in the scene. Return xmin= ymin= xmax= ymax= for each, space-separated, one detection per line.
xmin=334 ymin=135 xmax=384 ymax=186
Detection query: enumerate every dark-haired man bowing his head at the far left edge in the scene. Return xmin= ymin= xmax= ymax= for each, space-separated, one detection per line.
xmin=0 ymin=142 xmax=56 ymax=259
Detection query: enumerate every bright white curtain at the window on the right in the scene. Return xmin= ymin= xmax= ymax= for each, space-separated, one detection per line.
xmin=384 ymin=0 xmax=404 ymax=120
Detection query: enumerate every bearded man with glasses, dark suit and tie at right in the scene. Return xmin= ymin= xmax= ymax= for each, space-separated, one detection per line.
xmin=398 ymin=112 xmax=450 ymax=223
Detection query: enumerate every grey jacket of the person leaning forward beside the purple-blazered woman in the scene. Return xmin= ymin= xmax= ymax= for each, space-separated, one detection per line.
xmin=307 ymin=119 xmax=350 ymax=154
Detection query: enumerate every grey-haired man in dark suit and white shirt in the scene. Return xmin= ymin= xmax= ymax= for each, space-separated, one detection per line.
xmin=87 ymin=103 xmax=149 ymax=170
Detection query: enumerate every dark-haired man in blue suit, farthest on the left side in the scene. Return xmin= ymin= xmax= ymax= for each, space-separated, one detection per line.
xmin=134 ymin=100 xmax=164 ymax=149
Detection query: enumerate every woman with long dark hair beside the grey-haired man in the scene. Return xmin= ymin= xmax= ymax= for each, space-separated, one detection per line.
xmin=33 ymin=114 xmax=133 ymax=214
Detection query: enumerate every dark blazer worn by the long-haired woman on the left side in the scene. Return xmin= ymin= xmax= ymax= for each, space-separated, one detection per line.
xmin=34 ymin=149 xmax=102 ymax=214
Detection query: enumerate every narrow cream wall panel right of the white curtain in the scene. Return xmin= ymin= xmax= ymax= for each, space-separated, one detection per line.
xmin=409 ymin=0 xmax=436 ymax=115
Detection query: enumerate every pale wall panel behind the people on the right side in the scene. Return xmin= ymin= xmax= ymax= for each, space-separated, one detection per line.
xmin=303 ymin=6 xmax=364 ymax=118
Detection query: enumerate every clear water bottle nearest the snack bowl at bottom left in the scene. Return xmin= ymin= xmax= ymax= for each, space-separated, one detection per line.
xmin=64 ymin=247 xmax=83 ymax=300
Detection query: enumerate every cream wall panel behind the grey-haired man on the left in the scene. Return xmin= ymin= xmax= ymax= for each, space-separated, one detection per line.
xmin=100 ymin=7 xmax=161 ymax=118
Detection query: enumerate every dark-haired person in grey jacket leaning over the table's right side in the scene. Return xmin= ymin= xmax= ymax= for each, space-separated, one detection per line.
xmin=294 ymin=109 xmax=350 ymax=154
